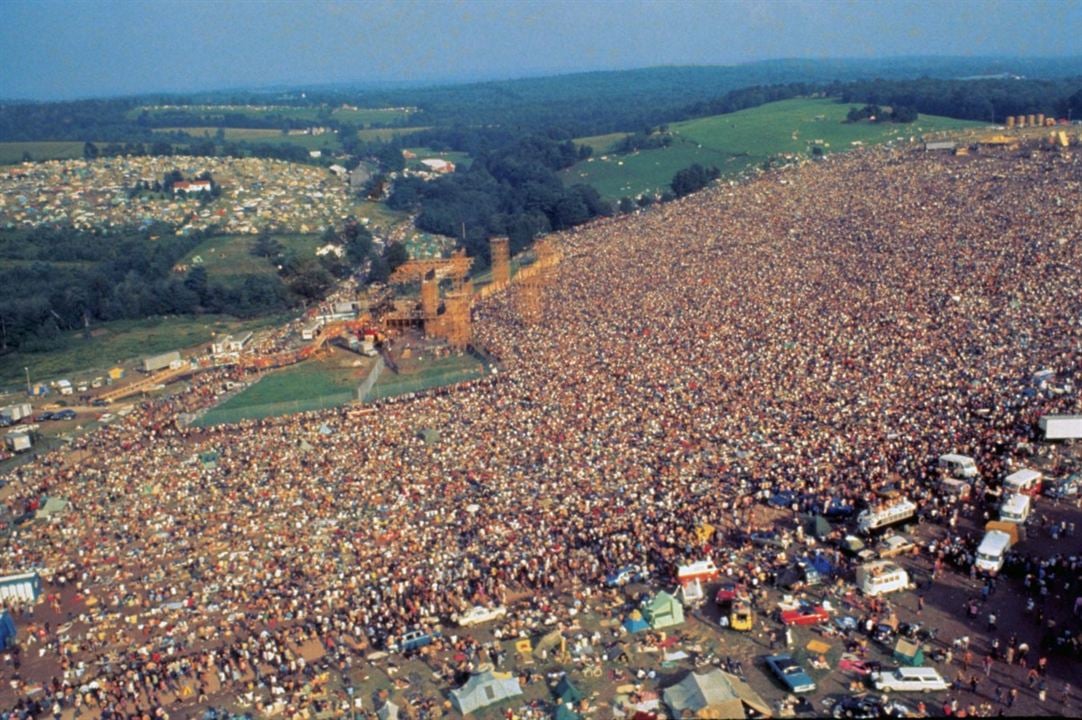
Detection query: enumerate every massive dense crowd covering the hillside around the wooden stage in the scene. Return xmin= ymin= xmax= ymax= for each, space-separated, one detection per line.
xmin=3 ymin=142 xmax=1082 ymax=717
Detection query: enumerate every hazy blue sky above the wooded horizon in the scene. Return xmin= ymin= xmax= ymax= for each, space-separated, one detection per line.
xmin=0 ymin=0 xmax=1082 ymax=100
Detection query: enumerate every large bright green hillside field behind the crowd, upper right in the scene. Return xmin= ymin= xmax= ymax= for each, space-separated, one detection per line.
xmin=560 ymin=99 xmax=984 ymax=199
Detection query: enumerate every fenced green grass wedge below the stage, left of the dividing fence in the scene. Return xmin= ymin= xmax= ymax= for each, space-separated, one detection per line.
xmin=195 ymin=361 xmax=368 ymax=427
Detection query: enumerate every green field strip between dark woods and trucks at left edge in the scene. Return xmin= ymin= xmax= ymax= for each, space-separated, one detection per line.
xmin=0 ymin=315 xmax=287 ymax=387
